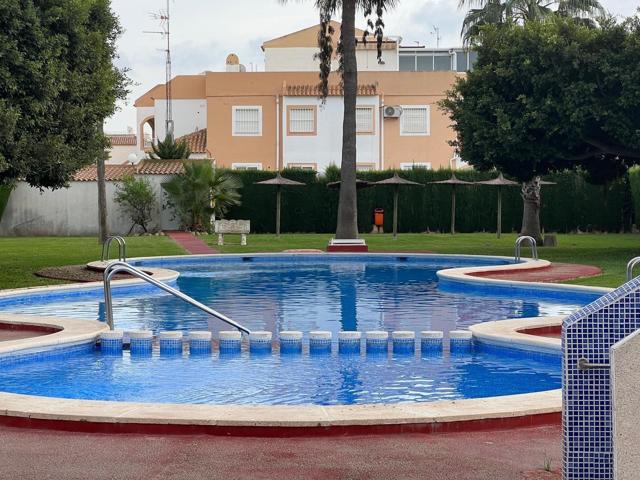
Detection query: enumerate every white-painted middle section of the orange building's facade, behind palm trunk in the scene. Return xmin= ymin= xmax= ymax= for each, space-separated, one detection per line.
xmin=281 ymin=96 xmax=380 ymax=172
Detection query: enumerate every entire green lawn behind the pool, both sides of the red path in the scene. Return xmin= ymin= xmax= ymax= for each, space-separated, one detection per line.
xmin=0 ymin=233 xmax=640 ymax=288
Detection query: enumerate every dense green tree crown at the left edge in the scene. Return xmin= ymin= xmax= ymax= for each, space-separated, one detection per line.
xmin=0 ymin=0 xmax=129 ymax=188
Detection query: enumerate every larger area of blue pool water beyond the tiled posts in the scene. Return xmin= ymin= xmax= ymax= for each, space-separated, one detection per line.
xmin=0 ymin=256 xmax=597 ymax=334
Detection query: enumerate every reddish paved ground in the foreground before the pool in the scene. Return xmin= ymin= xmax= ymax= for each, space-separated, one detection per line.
xmin=0 ymin=426 xmax=561 ymax=480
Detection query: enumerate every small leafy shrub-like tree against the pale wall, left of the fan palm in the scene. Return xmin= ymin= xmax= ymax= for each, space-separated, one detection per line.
xmin=114 ymin=175 xmax=157 ymax=233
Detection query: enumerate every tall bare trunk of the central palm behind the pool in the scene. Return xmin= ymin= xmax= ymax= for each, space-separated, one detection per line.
xmin=336 ymin=0 xmax=358 ymax=239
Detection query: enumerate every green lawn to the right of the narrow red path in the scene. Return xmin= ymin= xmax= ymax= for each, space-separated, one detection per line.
xmin=203 ymin=233 xmax=640 ymax=287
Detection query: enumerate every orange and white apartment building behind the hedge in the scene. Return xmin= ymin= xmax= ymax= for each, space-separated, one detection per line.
xmin=135 ymin=23 xmax=473 ymax=172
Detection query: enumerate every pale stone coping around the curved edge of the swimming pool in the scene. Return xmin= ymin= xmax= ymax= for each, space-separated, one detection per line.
xmin=0 ymin=253 xmax=610 ymax=436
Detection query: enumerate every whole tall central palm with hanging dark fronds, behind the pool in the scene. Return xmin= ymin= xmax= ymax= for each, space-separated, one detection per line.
xmin=280 ymin=0 xmax=396 ymax=239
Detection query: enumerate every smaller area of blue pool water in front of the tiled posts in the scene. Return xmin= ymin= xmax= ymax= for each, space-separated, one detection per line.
xmin=0 ymin=349 xmax=561 ymax=405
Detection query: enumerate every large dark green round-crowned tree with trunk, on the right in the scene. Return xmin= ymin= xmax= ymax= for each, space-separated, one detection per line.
xmin=441 ymin=18 xmax=640 ymax=239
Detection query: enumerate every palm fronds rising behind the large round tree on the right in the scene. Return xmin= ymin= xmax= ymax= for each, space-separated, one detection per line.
xmin=459 ymin=0 xmax=604 ymax=44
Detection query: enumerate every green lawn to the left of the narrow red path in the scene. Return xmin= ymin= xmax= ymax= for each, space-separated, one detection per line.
xmin=0 ymin=237 xmax=184 ymax=288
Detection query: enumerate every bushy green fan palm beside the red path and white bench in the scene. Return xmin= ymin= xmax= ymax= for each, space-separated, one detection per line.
xmin=162 ymin=160 xmax=242 ymax=231
